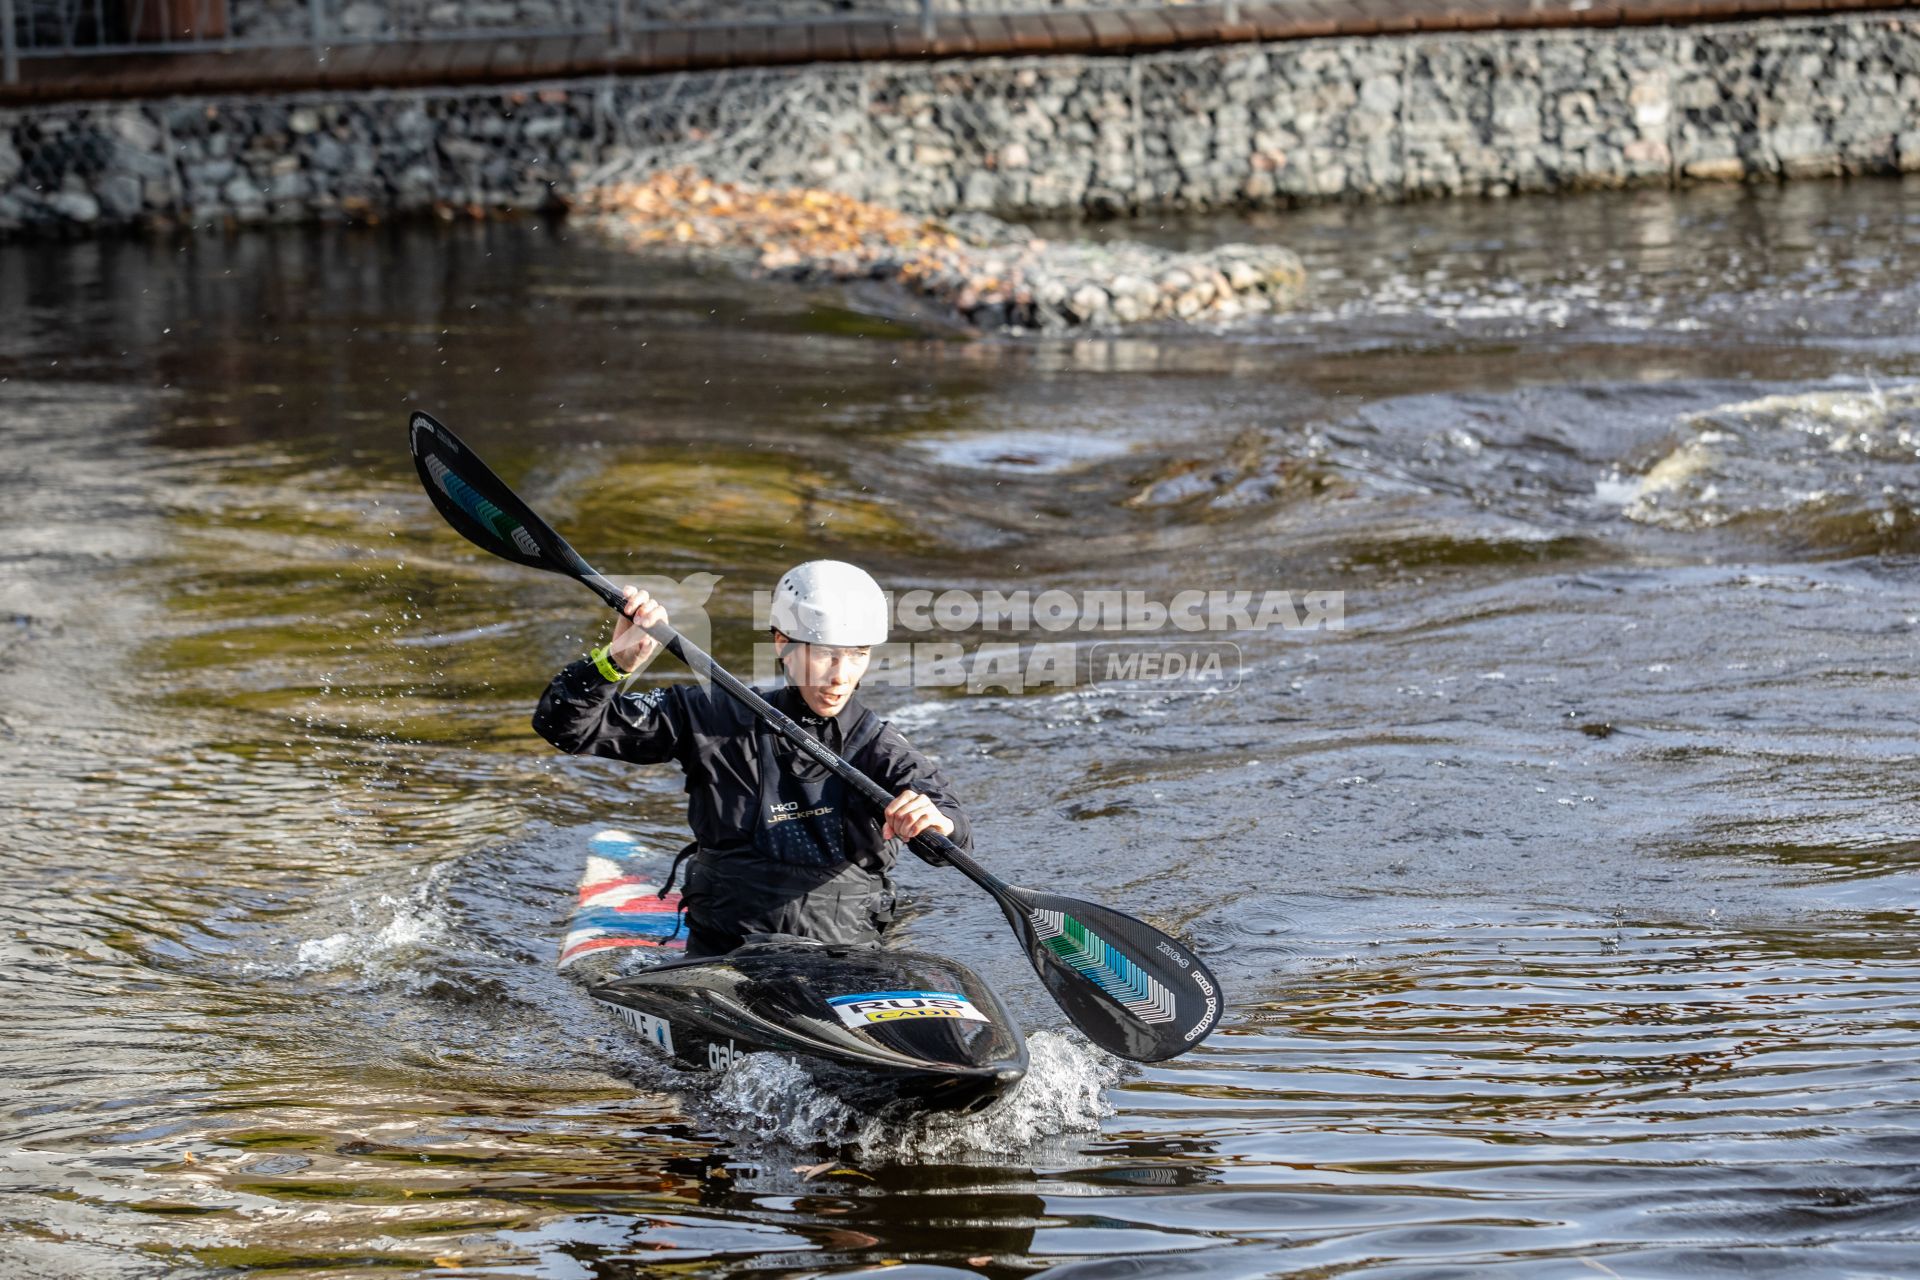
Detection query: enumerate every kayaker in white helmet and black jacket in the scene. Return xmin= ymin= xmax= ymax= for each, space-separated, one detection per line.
xmin=534 ymin=560 xmax=972 ymax=956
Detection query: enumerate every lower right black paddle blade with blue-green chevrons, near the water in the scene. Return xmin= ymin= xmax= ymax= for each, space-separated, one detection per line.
xmin=1000 ymin=885 xmax=1225 ymax=1063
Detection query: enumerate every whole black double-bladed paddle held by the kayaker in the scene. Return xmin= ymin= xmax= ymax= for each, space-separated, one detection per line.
xmin=409 ymin=413 xmax=1223 ymax=1061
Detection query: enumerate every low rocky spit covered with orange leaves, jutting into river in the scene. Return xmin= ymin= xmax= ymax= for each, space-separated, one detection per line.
xmin=584 ymin=171 xmax=1306 ymax=332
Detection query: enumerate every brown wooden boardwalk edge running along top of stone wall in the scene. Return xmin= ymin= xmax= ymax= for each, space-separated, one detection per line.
xmin=0 ymin=0 xmax=1920 ymax=104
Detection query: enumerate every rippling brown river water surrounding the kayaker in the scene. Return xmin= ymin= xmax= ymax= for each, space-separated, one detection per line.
xmin=0 ymin=182 xmax=1920 ymax=1280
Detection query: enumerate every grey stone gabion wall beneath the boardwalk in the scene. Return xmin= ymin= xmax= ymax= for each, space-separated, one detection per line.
xmin=0 ymin=15 xmax=1920 ymax=234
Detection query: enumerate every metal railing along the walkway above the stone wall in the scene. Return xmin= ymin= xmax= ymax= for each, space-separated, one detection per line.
xmin=0 ymin=0 xmax=1240 ymax=83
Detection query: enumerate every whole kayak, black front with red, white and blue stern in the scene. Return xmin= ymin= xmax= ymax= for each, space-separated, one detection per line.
xmin=561 ymin=831 xmax=1027 ymax=1113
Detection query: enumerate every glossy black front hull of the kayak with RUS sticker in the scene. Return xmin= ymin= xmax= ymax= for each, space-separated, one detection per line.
xmin=589 ymin=940 xmax=1027 ymax=1113
